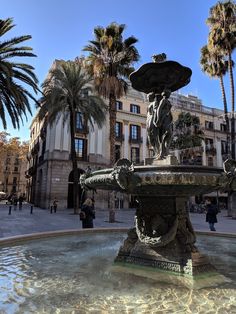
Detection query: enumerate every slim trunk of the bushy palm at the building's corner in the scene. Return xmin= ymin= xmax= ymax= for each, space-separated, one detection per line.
xmin=70 ymin=108 xmax=79 ymax=214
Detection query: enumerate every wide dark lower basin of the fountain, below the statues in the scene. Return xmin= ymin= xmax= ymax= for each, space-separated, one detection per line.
xmin=85 ymin=165 xmax=226 ymax=196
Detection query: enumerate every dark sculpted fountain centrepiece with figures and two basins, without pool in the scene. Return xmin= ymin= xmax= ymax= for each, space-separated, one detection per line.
xmin=81 ymin=54 xmax=233 ymax=286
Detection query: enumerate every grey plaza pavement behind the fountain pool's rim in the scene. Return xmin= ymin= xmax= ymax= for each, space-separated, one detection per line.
xmin=0 ymin=202 xmax=236 ymax=238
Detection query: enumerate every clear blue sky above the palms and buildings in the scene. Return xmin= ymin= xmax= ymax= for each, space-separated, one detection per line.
xmin=0 ymin=0 xmax=235 ymax=140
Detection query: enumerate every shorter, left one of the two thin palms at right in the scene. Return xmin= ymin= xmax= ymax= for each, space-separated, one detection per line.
xmin=200 ymin=45 xmax=230 ymax=154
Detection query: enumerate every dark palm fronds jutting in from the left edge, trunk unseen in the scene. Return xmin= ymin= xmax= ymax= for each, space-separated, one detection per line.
xmin=0 ymin=18 xmax=38 ymax=129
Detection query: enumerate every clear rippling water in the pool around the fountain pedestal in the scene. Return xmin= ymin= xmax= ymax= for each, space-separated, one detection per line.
xmin=0 ymin=233 xmax=236 ymax=314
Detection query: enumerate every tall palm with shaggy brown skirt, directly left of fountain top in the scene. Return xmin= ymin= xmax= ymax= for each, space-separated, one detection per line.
xmin=83 ymin=22 xmax=139 ymax=165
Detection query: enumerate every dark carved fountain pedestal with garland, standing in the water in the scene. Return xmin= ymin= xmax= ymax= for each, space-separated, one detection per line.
xmin=115 ymin=195 xmax=216 ymax=276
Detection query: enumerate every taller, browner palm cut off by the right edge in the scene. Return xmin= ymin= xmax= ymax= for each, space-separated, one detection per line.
xmin=207 ymin=1 xmax=236 ymax=159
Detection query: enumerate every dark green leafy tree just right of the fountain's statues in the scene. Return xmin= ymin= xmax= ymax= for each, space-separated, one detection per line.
xmin=171 ymin=112 xmax=204 ymax=149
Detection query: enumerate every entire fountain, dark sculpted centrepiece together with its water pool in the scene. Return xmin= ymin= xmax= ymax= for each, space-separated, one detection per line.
xmin=0 ymin=56 xmax=236 ymax=314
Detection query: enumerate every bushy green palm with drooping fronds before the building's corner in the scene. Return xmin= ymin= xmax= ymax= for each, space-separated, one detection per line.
xmin=38 ymin=59 xmax=106 ymax=214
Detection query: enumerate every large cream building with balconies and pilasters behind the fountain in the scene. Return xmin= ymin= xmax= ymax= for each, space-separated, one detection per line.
xmin=27 ymin=60 xmax=230 ymax=208
